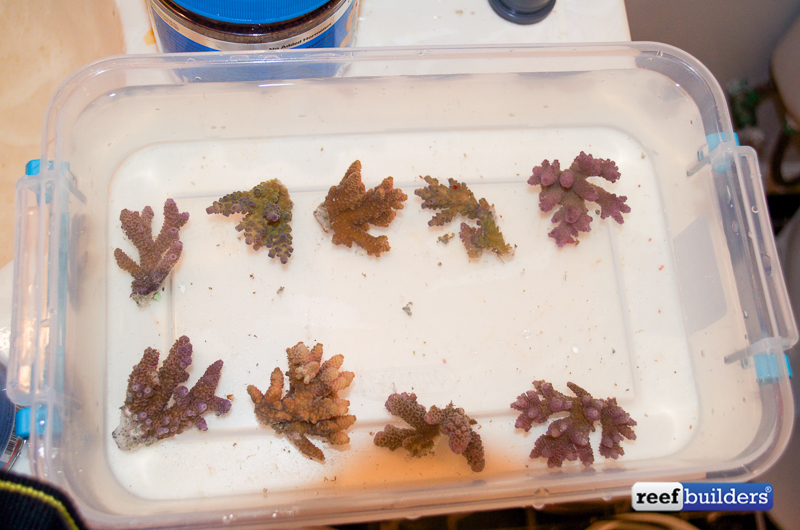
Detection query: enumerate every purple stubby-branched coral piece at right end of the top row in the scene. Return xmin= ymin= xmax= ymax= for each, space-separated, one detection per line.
xmin=528 ymin=151 xmax=631 ymax=247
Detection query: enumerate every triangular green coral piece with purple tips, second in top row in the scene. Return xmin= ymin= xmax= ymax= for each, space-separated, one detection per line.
xmin=206 ymin=179 xmax=294 ymax=264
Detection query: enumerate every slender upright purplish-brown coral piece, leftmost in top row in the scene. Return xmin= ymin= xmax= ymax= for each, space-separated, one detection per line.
xmin=114 ymin=199 xmax=189 ymax=304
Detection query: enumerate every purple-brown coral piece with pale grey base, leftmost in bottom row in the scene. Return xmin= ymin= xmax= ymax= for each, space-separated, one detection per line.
xmin=112 ymin=335 xmax=231 ymax=451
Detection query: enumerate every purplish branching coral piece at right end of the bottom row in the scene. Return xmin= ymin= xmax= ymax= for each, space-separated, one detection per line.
xmin=511 ymin=381 xmax=636 ymax=467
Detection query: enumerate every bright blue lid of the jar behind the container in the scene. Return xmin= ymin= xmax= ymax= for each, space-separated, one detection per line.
xmin=173 ymin=0 xmax=329 ymax=24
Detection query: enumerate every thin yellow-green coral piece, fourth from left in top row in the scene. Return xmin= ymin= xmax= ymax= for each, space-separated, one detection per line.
xmin=414 ymin=176 xmax=512 ymax=258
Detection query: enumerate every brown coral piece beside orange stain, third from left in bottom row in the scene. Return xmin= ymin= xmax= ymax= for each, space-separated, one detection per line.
xmin=374 ymin=392 xmax=486 ymax=472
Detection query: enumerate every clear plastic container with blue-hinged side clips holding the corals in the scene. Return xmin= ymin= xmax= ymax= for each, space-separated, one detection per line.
xmin=9 ymin=43 xmax=797 ymax=527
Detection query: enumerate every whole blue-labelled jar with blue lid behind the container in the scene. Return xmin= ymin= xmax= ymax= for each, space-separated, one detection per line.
xmin=148 ymin=0 xmax=358 ymax=53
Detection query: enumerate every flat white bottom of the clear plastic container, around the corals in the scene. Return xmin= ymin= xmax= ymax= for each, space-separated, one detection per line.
xmin=106 ymin=127 xmax=698 ymax=499
